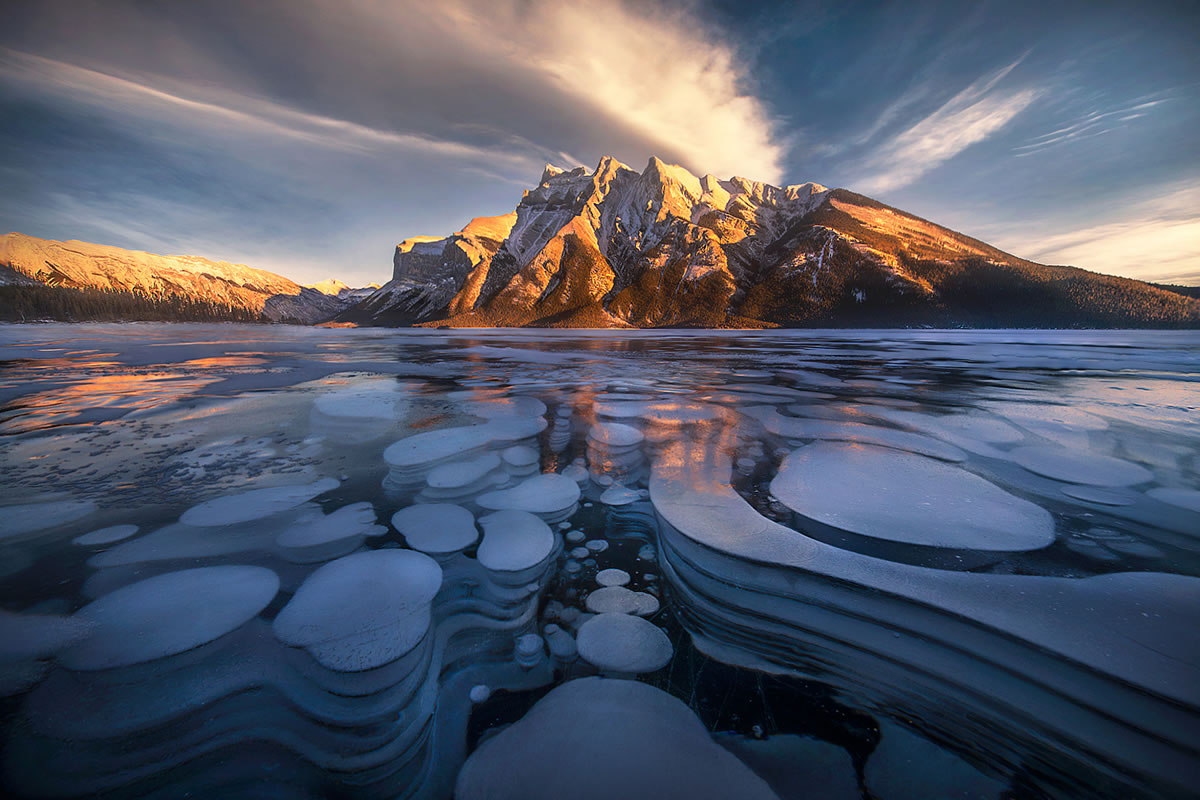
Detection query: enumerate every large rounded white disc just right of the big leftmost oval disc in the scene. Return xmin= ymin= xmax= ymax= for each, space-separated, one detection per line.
xmin=272 ymin=549 xmax=442 ymax=672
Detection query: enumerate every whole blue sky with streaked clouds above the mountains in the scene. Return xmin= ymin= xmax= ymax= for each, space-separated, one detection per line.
xmin=0 ymin=0 xmax=1200 ymax=285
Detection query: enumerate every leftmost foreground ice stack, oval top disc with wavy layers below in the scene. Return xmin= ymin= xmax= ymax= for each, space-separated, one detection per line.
xmin=5 ymin=566 xmax=295 ymax=796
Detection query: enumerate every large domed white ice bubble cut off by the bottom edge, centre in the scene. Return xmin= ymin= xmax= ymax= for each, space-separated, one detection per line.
xmin=454 ymin=678 xmax=778 ymax=800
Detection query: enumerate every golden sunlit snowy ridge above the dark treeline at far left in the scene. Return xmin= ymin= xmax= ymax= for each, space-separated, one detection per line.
xmin=0 ymin=233 xmax=368 ymax=323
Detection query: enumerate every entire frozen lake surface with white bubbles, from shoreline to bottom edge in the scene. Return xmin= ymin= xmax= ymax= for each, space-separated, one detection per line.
xmin=0 ymin=324 xmax=1200 ymax=800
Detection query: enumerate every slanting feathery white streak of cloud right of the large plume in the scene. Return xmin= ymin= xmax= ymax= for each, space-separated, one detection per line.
xmin=852 ymin=56 xmax=1042 ymax=193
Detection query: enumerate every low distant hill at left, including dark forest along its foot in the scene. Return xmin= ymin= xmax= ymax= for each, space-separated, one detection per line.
xmin=0 ymin=233 xmax=362 ymax=324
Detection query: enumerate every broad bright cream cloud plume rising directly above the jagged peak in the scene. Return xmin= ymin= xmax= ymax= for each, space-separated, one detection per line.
xmin=422 ymin=0 xmax=786 ymax=181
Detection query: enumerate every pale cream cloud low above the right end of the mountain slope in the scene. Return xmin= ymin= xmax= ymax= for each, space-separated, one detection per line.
xmin=995 ymin=180 xmax=1200 ymax=284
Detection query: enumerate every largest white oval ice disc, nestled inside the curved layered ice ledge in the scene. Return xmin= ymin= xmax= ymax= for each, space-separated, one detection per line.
xmin=770 ymin=441 xmax=1055 ymax=551
